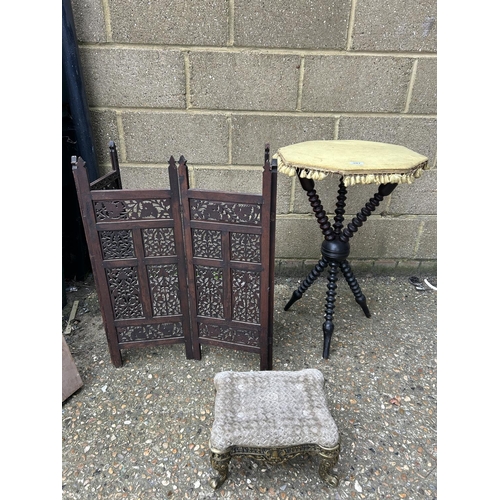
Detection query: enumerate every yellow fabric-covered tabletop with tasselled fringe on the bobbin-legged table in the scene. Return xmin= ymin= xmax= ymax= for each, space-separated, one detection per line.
xmin=273 ymin=140 xmax=429 ymax=186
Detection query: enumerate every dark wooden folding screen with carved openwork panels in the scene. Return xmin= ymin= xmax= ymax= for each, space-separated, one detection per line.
xmin=73 ymin=143 xmax=276 ymax=370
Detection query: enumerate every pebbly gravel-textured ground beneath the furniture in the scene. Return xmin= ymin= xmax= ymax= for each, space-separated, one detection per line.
xmin=62 ymin=276 xmax=437 ymax=500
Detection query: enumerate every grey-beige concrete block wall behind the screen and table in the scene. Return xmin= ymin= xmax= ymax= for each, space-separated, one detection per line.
xmin=72 ymin=0 xmax=437 ymax=276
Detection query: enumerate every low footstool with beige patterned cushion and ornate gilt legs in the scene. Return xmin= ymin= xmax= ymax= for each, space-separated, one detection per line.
xmin=210 ymin=369 xmax=340 ymax=489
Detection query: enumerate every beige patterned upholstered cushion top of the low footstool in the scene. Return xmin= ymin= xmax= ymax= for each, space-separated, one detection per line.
xmin=210 ymin=369 xmax=339 ymax=452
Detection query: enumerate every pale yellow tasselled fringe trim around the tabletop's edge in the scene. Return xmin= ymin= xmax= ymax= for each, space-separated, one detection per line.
xmin=278 ymin=157 xmax=429 ymax=186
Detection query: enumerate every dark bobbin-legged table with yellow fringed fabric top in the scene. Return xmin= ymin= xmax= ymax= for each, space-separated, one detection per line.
xmin=274 ymin=140 xmax=429 ymax=359
